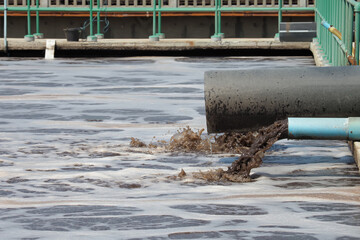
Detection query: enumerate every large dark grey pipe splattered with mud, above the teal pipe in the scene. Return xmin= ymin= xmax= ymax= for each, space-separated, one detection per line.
xmin=205 ymin=66 xmax=360 ymax=133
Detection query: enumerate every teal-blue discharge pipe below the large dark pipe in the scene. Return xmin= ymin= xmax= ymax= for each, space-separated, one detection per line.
xmin=288 ymin=117 xmax=360 ymax=141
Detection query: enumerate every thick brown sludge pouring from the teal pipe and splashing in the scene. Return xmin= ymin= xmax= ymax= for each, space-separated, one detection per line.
xmin=130 ymin=120 xmax=288 ymax=182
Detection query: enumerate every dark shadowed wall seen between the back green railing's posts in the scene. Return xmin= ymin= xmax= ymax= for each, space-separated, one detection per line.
xmin=0 ymin=17 xmax=313 ymax=38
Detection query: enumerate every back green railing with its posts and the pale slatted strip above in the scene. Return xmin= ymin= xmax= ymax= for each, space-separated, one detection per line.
xmin=0 ymin=0 xmax=315 ymax=41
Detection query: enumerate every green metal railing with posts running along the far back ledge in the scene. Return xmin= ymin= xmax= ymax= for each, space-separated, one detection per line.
xmin=0 ymin=0 xmax=314 ymax=40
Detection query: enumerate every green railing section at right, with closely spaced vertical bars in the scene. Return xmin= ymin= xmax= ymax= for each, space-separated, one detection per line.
xmin=315 ymin=0 xmax=360 ymax=66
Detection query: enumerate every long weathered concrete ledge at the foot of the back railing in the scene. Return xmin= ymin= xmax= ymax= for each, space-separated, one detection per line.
xmin=0 ymin=38 xmax=310 ymax=51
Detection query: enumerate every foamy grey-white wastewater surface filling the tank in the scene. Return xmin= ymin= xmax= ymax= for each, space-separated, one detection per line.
xmin=0 ymin=57 xmax=360 ymax=240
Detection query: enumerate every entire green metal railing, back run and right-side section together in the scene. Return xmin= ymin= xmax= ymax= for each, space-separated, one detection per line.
xmin=0 ymin=0 xmax=360 ymax=66
